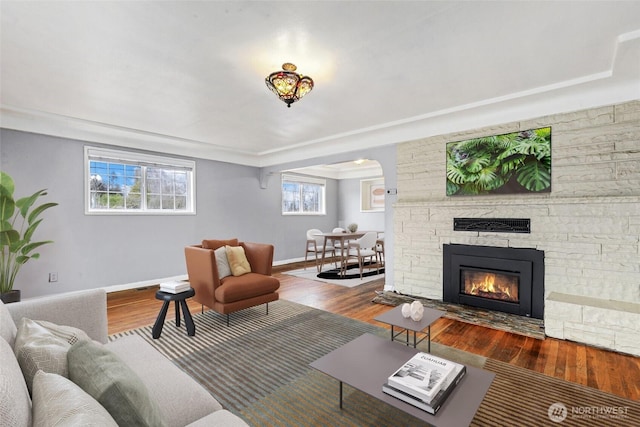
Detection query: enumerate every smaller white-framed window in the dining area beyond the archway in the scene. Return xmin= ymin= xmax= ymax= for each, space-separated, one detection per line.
xmin=282 ymin=174 xmax=327 ymax=215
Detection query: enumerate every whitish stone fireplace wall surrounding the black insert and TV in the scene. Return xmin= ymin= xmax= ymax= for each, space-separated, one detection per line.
xmin=394 ymin=101 xmax=640 ymax=355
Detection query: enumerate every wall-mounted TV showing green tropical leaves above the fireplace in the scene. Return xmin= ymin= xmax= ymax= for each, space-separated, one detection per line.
xmin=447 ymin=127 xmax=551 ymax=196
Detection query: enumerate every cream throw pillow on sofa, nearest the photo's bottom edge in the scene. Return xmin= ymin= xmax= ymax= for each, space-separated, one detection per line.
xmin=32 ymin=371 xmax=118 ymax=427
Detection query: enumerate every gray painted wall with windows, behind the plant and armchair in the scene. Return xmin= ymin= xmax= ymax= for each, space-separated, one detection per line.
xmin=0 ymin=129 xmax=348 ymax=298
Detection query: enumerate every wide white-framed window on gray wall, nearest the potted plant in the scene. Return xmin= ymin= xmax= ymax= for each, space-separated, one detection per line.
xmin=84 ymin=146 xmax=196 ymax=215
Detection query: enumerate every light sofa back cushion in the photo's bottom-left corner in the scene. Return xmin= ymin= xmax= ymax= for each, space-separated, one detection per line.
xmin=0 ymin=339 xmax=31 ymax=427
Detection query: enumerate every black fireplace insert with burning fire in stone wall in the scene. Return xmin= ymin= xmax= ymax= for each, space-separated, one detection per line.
xmin=443 ymin=244 xmax=544 ymax=319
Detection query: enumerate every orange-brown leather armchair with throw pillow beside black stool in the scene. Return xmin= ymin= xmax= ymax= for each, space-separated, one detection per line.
xmin=185 ymin=239 xmax=280 ymax=325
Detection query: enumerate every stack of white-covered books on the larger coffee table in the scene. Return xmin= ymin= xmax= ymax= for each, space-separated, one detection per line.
xmin=387 ymin=353 xmax=458 ymax=402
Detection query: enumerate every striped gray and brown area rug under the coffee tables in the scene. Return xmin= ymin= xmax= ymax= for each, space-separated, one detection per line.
xmin=110 ymin=300 xmax=640 ymax=427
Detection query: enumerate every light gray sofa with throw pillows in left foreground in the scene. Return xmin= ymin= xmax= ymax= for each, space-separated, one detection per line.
xmin=0 ymin=290 xmax=247 ymax=427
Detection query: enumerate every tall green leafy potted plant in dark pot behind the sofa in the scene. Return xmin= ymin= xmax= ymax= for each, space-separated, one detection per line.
xmin=0 ymin=171 xmax=57 ymax=303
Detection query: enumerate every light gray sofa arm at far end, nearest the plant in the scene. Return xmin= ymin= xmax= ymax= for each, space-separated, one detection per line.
xmin=6 ymin=289 xmax=109 ymax=344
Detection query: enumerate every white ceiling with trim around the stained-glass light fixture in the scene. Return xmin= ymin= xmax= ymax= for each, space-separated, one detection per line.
xmin=0 ymin=0 xmax=640 ymax=166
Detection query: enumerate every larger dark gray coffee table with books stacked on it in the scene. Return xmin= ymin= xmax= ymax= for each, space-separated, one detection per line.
xmin=310 ymin=334 xmax=495 ymax=427
